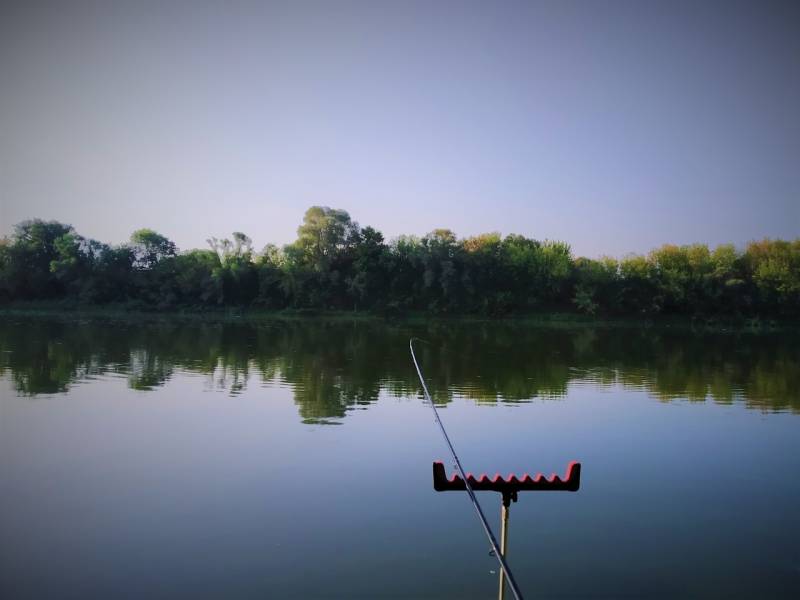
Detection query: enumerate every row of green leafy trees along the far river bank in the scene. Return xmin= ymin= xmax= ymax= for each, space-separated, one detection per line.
xmin=0 ymin=206 xmax=800 ymax=317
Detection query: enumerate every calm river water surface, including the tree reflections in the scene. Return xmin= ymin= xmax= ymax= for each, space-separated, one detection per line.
xmin=0 ymin=318 xmax=800 ymax=598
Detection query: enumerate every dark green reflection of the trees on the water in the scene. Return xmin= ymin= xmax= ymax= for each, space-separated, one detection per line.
xmin=0 ymin=319 xmax=800 ymax=423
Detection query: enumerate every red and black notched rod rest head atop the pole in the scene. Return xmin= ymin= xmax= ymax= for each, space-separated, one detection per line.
xmin=433 ymin=460 xmax=581 ymax=501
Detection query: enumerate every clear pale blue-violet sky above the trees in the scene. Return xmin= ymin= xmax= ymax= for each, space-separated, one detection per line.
xmin=0 ymin=0 xmax=800 ymax=256
